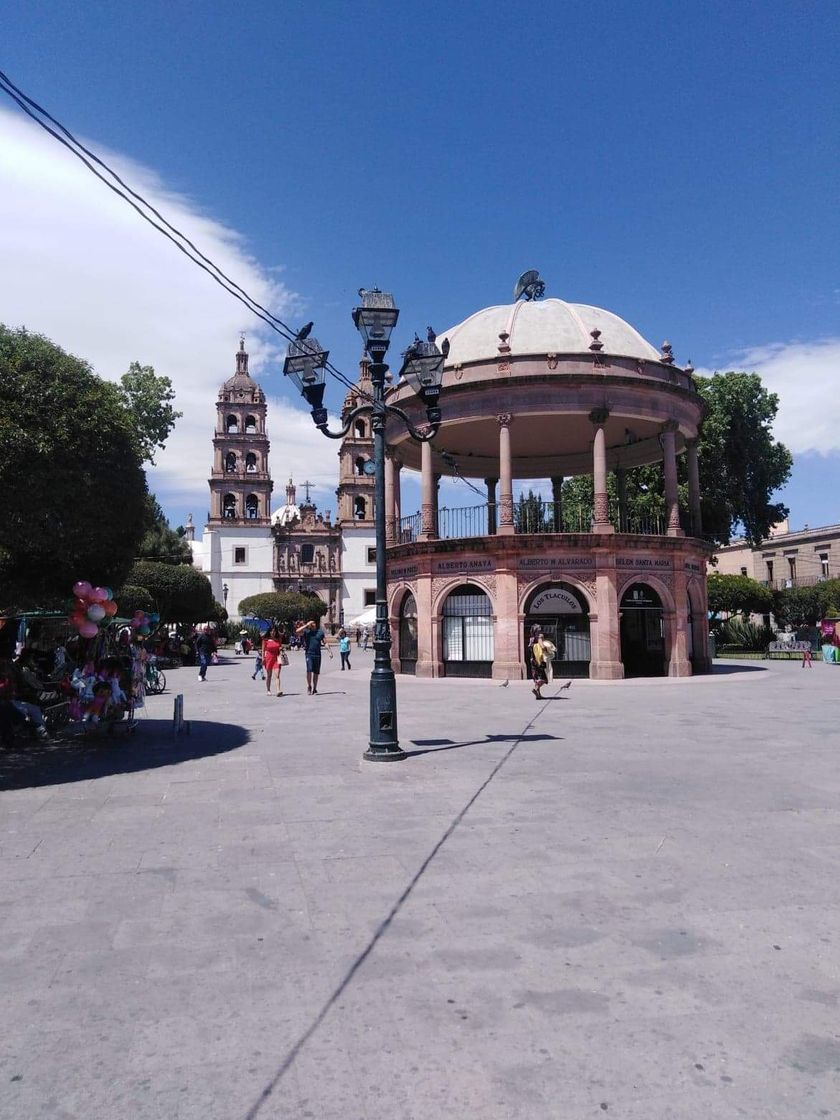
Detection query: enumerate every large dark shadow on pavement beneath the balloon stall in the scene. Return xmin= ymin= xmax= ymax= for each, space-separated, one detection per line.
xmin=0 ymin=719 xmax=251 ymax=790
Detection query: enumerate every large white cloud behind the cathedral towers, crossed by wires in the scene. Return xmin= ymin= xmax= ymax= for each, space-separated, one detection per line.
xmin=0 ymin=109 xmax=337 ymax=525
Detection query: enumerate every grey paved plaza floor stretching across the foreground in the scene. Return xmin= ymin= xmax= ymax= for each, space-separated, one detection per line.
xmin=0 ymin=651 xmax=840 ymax=1120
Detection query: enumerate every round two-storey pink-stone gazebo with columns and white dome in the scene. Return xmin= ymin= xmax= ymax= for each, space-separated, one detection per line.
xmin=385 ymin=288 xmax=710 ymax=679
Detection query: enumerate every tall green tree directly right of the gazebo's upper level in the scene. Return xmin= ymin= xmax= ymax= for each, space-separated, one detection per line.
xmin=696 ymin=372 xmax=793 ymax=544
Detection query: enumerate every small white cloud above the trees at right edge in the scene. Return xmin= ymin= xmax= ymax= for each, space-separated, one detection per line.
xmin=698 ymin=338 xmax=840 ymax=455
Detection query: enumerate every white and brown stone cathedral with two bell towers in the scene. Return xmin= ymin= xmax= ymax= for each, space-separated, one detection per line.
xmin=187 ymin=338 xmax=376 ymax=629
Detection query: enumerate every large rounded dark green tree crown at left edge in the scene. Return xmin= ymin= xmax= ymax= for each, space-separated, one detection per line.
xmin=0 ymin=325 xmax=147 ymax=612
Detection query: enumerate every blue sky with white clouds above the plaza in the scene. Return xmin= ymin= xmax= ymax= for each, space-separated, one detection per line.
xmin=0 ymin=0 xmax=840 ymax=528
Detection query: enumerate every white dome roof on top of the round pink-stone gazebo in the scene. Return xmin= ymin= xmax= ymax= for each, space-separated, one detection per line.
xmin=438 ymin=299 xmax=662 ymax=367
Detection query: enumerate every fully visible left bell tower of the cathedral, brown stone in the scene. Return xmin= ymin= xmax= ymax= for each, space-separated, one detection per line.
xmin=207 ymin=338 xmax=273 ymax=529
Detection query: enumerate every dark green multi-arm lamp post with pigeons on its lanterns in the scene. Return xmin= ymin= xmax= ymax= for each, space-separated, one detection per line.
xmin=283 ymin=288 xmax=449 ymax=762
